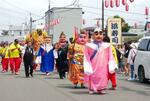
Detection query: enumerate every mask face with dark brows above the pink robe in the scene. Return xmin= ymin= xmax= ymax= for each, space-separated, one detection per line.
xmin=93 ymin=31 xmax=104 ymax=42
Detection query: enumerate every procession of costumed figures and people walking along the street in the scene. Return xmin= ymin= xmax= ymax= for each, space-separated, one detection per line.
xmin=0 ymin=28 xmax=136 ymax=94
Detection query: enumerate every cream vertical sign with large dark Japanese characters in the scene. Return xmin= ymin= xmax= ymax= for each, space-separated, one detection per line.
xmin=107 ymin=18 xmax=122 ymax=44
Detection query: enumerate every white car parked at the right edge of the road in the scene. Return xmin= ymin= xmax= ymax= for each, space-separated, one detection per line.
xmin=134 ymin=37 xmax=150 ymax=82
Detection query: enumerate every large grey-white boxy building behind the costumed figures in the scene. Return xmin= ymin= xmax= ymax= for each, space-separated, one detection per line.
xmin=45 ymin=7 xmax=82 ymax=43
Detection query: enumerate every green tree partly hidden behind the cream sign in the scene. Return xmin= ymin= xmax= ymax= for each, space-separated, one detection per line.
xmin=113 ymin=15 xmax=130 ymax=32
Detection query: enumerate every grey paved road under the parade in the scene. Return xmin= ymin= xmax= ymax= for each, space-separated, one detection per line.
xmin=0 ymin=66 xmax=150 ymax=101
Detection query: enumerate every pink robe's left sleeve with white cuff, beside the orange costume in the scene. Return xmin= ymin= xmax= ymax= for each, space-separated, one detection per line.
xmin=83 ymin=46 xmax=93 ymax=75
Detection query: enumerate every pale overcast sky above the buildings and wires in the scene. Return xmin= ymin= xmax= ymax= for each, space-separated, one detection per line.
xmin=0 ymin=0 xmax=150 ymax=29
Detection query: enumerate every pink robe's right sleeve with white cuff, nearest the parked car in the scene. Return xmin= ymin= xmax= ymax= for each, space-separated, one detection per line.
xmin=108 ymin=46 xmax=118 ymax=73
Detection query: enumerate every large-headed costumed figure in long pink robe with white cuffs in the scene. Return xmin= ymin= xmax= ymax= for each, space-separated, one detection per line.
xmin=84 ymin=28 xmax=117 ymax=94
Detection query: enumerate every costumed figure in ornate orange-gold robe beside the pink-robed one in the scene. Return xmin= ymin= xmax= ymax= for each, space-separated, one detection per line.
xmin=68 ymin=31 xmax=87 ymax=88
